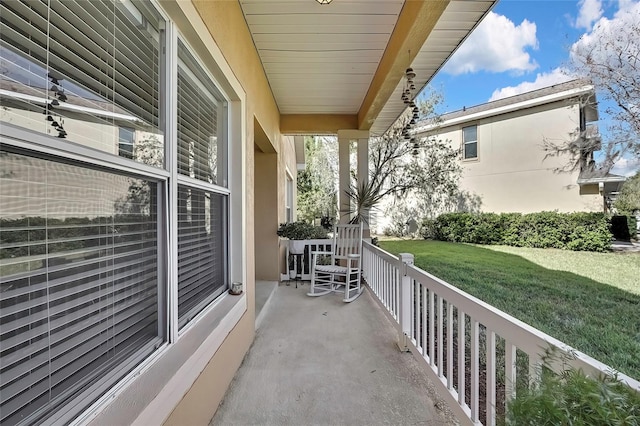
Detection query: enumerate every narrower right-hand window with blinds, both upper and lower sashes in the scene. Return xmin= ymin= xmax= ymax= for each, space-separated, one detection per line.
xmin=178 ymin=41 xmax=229 ymax=327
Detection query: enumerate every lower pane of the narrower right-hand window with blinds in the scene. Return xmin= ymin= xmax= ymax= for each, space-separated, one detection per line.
xmin=178 ymin=185 xmax=228 ymax=327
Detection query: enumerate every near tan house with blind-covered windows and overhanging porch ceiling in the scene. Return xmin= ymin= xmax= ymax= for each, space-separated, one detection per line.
xmin=0 ymin=0 xmax=495 ymax=426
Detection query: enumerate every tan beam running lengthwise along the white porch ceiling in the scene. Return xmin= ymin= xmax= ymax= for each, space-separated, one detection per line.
xmin=357 ymin=0 xmax=449 ymax=130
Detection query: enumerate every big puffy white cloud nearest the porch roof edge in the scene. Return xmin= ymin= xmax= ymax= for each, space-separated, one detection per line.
xmin=443 ymin=12 xmax=538 ymax=75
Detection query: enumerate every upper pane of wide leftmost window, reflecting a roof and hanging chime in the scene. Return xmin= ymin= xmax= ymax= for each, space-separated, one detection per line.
xmin=0 ymin=0 xmax=164 ymax=167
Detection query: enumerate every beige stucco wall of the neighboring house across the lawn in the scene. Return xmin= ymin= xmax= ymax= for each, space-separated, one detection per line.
xmin=420 ymin=95 xmax=602 ymax=213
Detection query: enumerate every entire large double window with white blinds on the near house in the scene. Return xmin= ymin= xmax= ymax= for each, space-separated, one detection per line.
xmin=0 ymin=0 xmax=232 ymax=426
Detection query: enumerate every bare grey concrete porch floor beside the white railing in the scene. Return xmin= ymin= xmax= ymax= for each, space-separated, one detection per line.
xmin=210 ymin=283 xmax=454 ymax=425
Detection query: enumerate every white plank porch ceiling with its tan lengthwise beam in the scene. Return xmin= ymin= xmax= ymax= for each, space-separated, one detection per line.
xmin=240 ymin=0 xmax=496 ymax=134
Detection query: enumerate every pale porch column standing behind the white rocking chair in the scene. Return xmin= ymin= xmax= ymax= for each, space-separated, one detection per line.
xmin=338 ymin=129 xmax=369 ymax=223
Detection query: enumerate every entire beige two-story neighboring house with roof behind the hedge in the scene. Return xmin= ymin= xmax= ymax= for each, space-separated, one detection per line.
xmin=416 ymin=80 xmax=624 ymax=213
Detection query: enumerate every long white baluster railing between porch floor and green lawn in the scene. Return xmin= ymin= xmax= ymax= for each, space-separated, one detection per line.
xmin=363 ymin=243 xmax=640 ymax=425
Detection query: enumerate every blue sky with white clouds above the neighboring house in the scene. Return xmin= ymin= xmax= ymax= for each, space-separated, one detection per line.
xmin=422 ymin=0 xmax=640 ymax=174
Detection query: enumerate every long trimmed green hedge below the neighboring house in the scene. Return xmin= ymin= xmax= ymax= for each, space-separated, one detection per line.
xmin=422 ymin=212 xmax=611 ymax=251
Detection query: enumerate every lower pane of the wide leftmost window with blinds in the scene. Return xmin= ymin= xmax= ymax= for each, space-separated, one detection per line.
xmin=0 ymin=150 xmax=162 ymax=426
